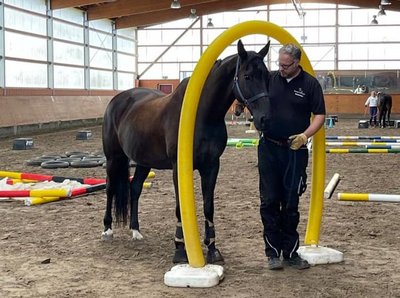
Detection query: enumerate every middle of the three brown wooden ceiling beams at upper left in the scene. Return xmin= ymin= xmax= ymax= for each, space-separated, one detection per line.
xmin=87 ymin=0 xmax=218 ymax=21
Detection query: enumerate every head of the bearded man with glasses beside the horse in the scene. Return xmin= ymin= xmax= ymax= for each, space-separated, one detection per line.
xmin=277 ymin=43 xmax=301 ymax=78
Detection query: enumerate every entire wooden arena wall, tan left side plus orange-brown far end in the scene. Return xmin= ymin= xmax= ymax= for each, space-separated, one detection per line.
xmin=0 ymin=80 xmax=400 ymax=137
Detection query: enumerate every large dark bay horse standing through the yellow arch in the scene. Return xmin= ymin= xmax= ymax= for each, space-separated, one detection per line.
xmin=102 ymin=40 xmax=270 ymax=263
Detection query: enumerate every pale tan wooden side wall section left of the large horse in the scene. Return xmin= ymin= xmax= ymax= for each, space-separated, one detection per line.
xmin=0 ymin=96 xmax=112 ymax=137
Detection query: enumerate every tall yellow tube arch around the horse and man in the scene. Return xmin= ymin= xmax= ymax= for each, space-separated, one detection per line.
xmin=178 ymin=21 xmax=325 ymax=268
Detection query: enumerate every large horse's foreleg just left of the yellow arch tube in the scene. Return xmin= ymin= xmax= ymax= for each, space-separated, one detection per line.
xmin=172 ymin=165 xmax=188 ymax=263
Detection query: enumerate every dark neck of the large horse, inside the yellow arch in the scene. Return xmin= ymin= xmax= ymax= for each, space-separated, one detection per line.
xmin=197 ymin=58 xmax=236 ymax=122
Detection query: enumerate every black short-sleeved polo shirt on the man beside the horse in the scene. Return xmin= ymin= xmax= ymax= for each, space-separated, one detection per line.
xmin=264 ymin=69 xmax=325 ymax=140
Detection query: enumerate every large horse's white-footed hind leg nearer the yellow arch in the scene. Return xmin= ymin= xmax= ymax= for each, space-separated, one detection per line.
xmin=129 ymin=165 xmax=150 ymax=240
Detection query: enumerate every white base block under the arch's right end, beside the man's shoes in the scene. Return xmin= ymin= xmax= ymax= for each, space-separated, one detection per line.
xmin=297 ymin=246 xmax=343 ymax=265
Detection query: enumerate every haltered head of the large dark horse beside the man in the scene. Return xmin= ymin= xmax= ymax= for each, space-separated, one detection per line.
xmin=233 ymin=40 xmax=271 ymax=130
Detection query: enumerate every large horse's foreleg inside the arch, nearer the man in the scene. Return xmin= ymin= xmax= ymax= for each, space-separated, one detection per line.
xmin=199 ymin=160 xmax=224 ymax=264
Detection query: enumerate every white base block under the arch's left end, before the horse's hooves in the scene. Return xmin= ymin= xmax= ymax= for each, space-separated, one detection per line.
xmin=164 ymin=264 xmax=224 ymax=288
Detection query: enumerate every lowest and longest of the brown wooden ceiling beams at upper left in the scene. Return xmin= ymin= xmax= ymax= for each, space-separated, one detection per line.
xmin=115 ymin=0 xmax=265 ymax=29
